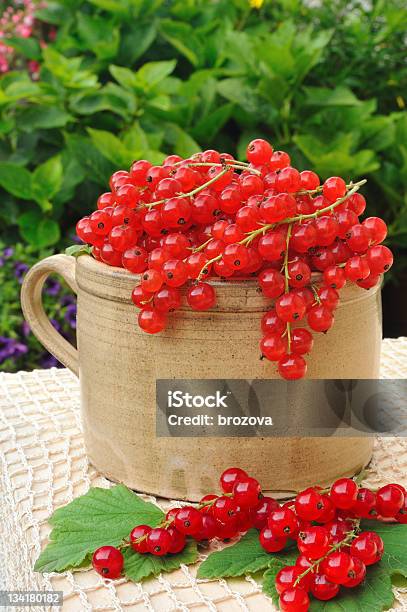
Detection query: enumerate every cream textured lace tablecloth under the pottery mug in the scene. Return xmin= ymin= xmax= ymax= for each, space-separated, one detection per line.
xmin=0 ymin=338 xmax=407 ymax=612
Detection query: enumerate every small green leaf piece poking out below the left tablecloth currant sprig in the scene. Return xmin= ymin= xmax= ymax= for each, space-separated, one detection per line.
xmin=123 ymin=541 xmax=198 ymax=582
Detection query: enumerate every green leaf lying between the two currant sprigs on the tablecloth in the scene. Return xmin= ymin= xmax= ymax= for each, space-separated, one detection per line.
xmin=198 ymin=529 xmax=294 ymax=578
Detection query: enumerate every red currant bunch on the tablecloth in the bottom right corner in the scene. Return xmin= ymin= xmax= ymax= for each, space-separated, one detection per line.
xmin=266 ymin=478 xmax=407 ymax=612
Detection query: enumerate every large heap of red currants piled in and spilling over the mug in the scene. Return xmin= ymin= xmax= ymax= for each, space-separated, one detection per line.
xmin=76 ymin=139 xmax=393 ymax=379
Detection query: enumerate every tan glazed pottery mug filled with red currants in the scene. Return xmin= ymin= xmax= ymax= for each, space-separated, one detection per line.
xmin=22 ymin=255 xmax=382 ymax=501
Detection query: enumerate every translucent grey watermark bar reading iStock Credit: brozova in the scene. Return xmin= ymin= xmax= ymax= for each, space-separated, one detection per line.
xmin=156 ymin=379 xmax=407 ymax=437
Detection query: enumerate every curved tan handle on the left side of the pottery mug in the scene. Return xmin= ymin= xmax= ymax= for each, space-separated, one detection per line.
xmin=21 ymin=255 xmax=79 ymax=376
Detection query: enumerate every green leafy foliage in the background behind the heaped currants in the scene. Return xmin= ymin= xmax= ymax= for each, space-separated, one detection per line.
xmin=0 ymin=0 xmax=407 ymax=368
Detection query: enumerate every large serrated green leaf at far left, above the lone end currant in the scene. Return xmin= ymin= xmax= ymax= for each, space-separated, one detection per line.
xmin=34 ymin=485 xmax=164 ymax=572
